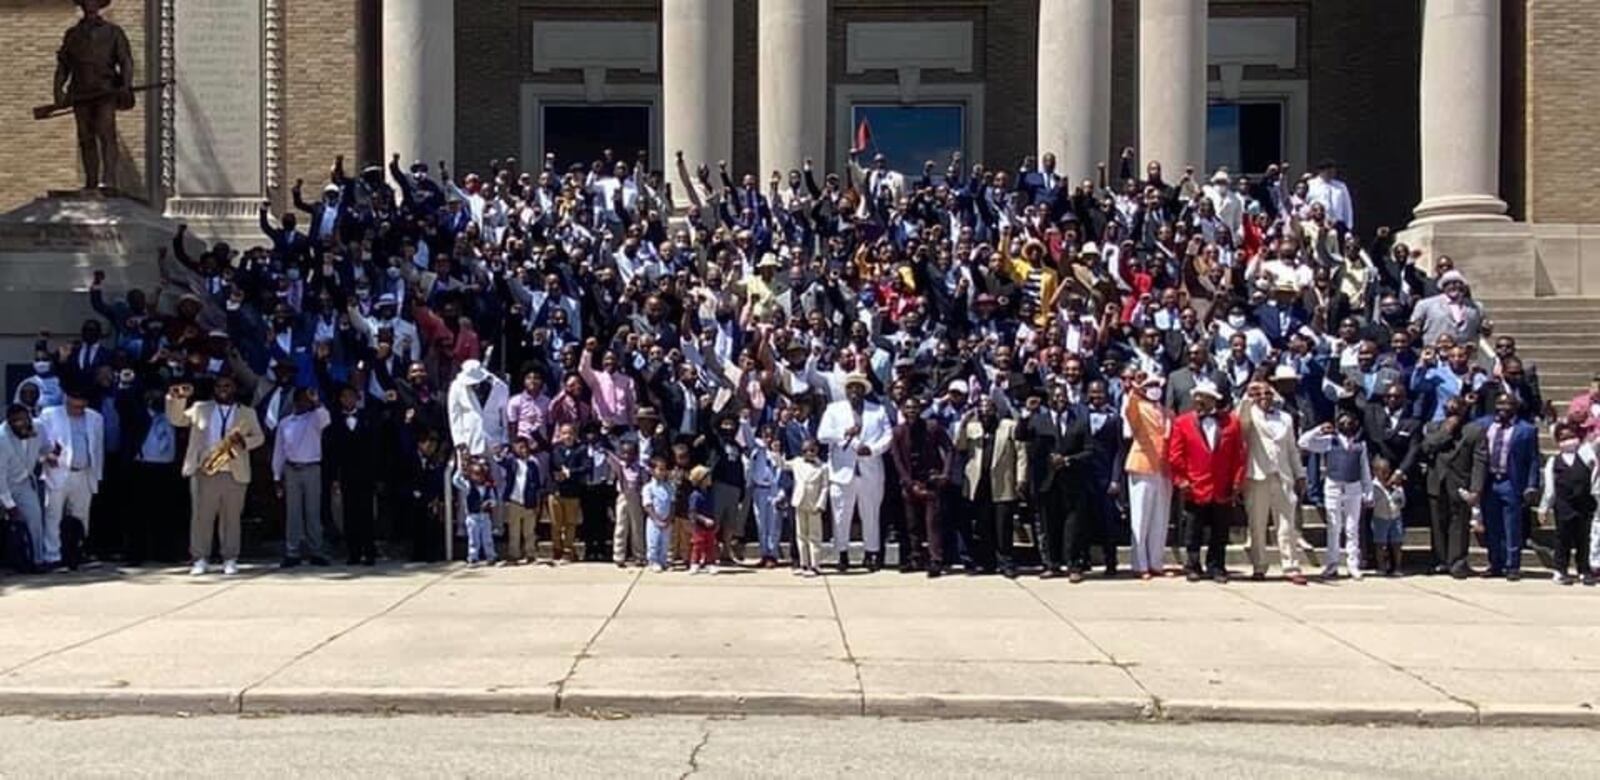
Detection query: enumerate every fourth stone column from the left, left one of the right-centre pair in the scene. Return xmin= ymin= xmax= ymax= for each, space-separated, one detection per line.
xmin=1038 ymin=0 xmax=1110 ymax=181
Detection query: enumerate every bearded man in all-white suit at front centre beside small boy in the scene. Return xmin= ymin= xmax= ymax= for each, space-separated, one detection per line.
xmin=816 ymin=372 xmax=894 ymax=571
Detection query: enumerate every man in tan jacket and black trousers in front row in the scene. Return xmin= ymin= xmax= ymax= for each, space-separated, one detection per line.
xmin=955 ymin=395 xmax=1027 ymax=577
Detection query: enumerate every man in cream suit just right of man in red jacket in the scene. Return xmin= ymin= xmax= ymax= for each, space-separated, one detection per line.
xmin=1238 ymin=374 xmax=1306 ymax=585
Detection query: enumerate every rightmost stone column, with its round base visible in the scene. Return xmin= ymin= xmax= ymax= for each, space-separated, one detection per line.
xmin=1413 ymin=0 xmax=1509 ymax=224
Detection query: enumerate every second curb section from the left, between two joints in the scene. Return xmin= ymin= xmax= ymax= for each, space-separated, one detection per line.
xmin=238 ymin=686 xmax=555 ymax=714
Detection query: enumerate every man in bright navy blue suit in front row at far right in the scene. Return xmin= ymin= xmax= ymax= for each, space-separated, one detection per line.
xmin=1478 ymin=395 xmax=1541 ymax=580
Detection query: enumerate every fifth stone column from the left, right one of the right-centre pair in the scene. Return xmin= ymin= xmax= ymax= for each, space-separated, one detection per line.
xmin=1139 ymin=0 xmax=1206 ymax=175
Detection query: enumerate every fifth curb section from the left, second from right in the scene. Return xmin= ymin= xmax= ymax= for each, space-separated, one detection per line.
xmin=1162 ymin=698 xmax=1478 ymax=726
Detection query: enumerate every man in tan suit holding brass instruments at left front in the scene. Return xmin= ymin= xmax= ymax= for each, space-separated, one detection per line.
xmin=166 ymin=376 xmax=267 ymax=575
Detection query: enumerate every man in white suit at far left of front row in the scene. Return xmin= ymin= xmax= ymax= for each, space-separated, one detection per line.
xmin=38 ymin=382 xmax=106 ymax=567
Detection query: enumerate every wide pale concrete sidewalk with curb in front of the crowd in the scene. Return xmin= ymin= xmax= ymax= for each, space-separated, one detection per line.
xmin=0 ymin=566 xmax=1600 ymax=726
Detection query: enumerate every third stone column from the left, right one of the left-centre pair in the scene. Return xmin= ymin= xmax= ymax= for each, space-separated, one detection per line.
xmin=757 ymin=0 xmax=827 ymax=176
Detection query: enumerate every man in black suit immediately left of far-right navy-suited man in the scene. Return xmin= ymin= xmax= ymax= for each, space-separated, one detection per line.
xmin=1421 ymin=398 xmax=1490 ymax=580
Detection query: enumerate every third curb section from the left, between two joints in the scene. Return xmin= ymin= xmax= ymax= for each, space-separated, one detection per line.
xmin=557 ymin=689 xmax=861 ymax=716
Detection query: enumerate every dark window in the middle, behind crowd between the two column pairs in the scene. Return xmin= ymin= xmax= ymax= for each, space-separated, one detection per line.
xmin=850 ymin=102 xmax=966 ymax=176
